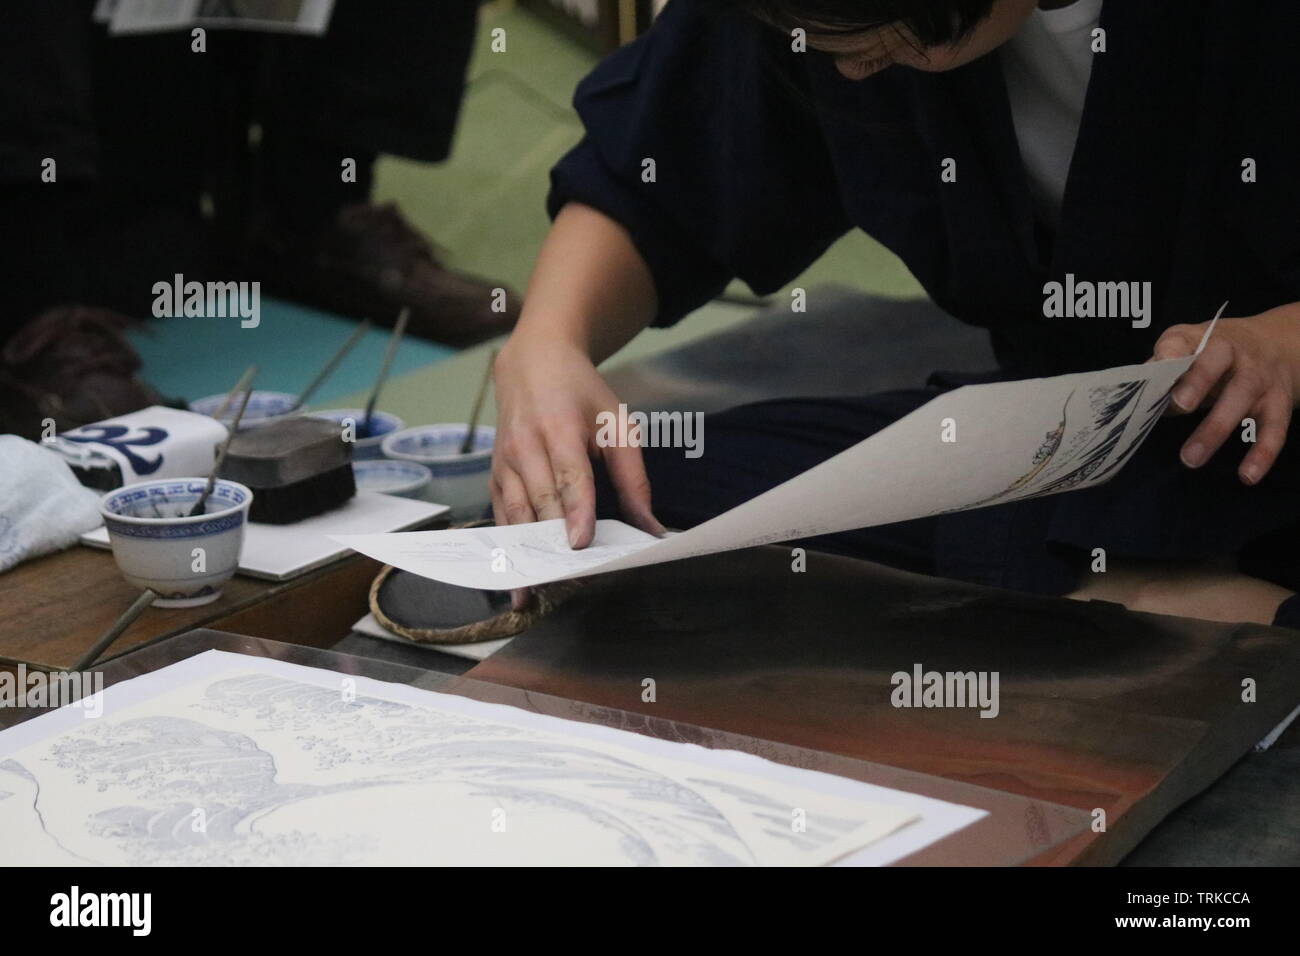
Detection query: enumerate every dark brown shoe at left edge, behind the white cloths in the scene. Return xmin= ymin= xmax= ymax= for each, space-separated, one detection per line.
xmin=0 ymin=306 xmax=166 ymax=440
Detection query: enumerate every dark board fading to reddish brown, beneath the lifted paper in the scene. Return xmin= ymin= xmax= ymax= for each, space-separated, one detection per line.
xmin=467 ymin=548 xmax=1300 ymax=864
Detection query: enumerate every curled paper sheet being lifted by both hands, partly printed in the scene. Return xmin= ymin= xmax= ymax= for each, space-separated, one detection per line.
xmin=337 ymin=323 xmax=1222 ymax=591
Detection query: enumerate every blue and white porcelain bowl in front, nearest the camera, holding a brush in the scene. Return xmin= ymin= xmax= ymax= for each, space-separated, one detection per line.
xmin=99 ymin=477 xmax=252 ymax=607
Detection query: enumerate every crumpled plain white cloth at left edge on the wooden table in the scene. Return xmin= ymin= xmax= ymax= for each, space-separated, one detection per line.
xmin=0 ymin=434 xmax=100 ymax=571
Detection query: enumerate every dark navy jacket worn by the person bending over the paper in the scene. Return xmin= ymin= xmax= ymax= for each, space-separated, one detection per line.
xmin=549 ymin=0 xmax=1300 ymax=373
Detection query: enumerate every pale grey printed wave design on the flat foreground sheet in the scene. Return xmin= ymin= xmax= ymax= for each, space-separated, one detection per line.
xmin=0 ymin=675 xmax=861 ymax=865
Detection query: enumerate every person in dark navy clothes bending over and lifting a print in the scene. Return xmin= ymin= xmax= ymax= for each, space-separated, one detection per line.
xmin=491 ymin=0 xmax=1300 ymax=626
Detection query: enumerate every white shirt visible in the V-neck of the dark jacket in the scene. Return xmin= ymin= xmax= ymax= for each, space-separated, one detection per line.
xmin=1002 ymin=0 xmax=1102 ymax=228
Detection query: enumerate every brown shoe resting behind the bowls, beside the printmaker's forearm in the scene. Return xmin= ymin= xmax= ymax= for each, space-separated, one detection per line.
xmin=251 ymin=203 xmax=520 ymax=346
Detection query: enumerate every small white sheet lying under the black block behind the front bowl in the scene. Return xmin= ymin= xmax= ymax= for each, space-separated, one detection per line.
xmin=81 ymin=492 xmax=447 ymax=581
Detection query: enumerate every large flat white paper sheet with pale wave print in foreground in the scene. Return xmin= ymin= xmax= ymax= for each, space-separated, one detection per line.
xmin=0 ymin=650 xmax=985 ymax=865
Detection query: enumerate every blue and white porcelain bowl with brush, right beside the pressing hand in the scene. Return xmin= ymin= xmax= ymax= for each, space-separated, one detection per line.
xmin=384 ymin=424 xmax=497 ymax=522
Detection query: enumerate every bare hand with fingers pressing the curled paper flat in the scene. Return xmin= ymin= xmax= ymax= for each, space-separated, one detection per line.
xmin=489 ymin=334 xmax=663 ymax=548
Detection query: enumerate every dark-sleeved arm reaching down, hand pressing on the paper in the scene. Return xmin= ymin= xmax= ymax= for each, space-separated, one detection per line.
xmin=491 ymin=0 xmax=850 ymax=574
